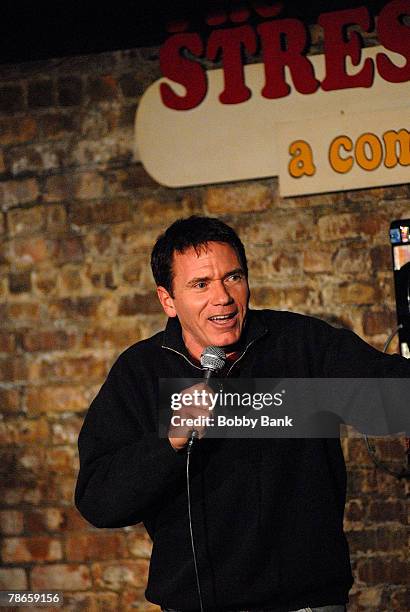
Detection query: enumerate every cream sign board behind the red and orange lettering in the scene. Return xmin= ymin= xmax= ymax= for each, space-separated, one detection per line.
xmin=136 ymin=47 xmax=410 ymax=195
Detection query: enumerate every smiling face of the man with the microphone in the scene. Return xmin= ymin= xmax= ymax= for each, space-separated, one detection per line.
xmin=158 ymin=242 xmax=249 ymax=359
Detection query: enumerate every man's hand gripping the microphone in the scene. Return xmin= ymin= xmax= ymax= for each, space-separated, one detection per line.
xmin=168 ymin=382 xmax=214 ymax=450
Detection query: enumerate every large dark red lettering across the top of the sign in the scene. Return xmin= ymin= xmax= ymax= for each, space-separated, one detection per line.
xmin=160 ymin=0 xmax=410 ymax=110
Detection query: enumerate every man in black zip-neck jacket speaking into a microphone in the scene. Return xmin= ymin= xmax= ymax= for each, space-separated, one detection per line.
xmin=76 ymin=217 xmax=410 ymax=612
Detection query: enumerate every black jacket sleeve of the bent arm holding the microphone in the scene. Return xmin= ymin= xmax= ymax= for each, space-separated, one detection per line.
xmin=75 ymin=357 xmax=185 ymax=527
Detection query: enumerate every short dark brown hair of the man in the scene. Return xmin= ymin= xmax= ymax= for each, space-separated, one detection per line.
xmin=151 ymin=215 xmax=248 ymax=295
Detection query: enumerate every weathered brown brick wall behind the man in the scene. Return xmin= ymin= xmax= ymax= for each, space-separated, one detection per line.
xmin=0 ymin=28 xmax=410 ymax=612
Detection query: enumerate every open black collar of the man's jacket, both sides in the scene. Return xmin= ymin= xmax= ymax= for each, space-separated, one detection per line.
xmin=162 ymin=310 xmax=268 ymax=370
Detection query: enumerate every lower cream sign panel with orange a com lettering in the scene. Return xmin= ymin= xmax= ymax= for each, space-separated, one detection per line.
xmin=278 ymin=110 xmax=410 ymax=196
